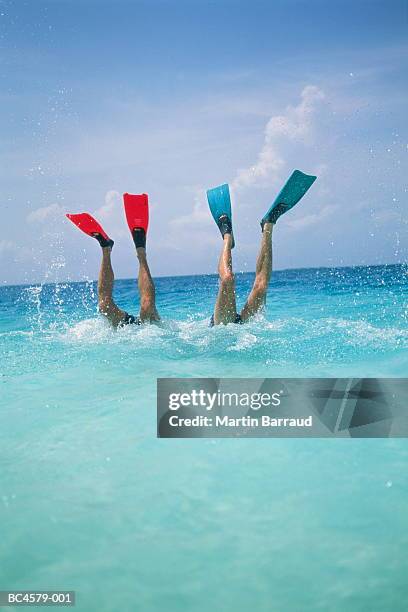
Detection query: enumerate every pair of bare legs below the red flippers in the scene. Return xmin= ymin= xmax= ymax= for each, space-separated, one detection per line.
xmin=98 ymin=247 xmax=160 ymax=327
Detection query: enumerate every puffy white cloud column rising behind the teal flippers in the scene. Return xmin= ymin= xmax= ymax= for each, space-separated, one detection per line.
xmin=232 ymin=85 xmax=324 ymax=189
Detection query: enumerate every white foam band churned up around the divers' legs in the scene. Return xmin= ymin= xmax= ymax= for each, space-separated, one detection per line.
xmin=52 ymin=316 xmax=408 ymax=354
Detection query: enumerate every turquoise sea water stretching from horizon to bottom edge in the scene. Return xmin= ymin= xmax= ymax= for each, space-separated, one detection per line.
xmin=0 ymin=266 xmax=408 ymax=612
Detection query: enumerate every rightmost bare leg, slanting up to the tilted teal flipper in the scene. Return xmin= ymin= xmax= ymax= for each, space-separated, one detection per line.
xmin=241 ymin=223 xmax=274 ymax=321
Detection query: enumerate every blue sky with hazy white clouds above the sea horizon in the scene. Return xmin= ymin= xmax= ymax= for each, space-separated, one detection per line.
xmin=0 ymin=0 xmax=408 ymax=284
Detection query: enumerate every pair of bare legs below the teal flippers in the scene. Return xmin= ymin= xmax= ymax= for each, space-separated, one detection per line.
xmin=214 ymin=223 xmax=274 ymax=325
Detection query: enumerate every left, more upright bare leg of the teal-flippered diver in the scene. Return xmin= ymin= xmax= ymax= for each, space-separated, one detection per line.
xmin=214 ymin=234 xmax=237 ymax=325
